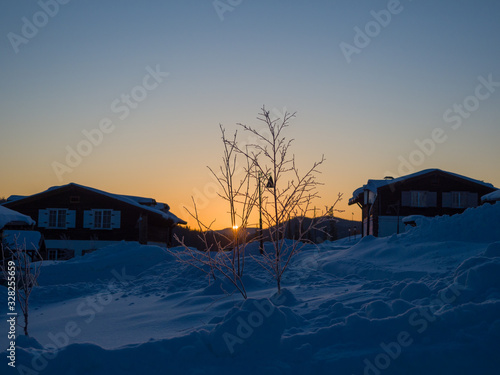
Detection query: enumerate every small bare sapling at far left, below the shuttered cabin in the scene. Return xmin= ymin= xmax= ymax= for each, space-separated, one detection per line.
xmin=0 ymin=237 xmax=42 ymax=336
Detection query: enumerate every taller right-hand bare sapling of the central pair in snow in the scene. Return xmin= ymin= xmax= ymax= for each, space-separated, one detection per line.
xmin=230 ymin=107 xmax=332 ymax=292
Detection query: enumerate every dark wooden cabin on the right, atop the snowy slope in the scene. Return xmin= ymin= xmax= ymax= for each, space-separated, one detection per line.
xmin=349 ymin=169 xmax=497 ymax=237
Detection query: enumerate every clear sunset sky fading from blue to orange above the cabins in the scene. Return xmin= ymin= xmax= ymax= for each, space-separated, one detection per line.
xmin=0 ymin=0 xmax=500 ymax=228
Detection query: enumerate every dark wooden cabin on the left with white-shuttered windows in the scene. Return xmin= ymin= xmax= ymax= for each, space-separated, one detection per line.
xmin=3 ymin=183 xmax=186 ymax=259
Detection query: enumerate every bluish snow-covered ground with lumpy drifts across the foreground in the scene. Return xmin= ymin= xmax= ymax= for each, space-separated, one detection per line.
xmin=0 ymin=203 xmax=500 ymax=375
